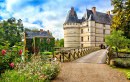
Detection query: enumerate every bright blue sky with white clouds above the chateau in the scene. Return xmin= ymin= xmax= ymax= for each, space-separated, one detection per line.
xmin=0 ymin=0 xmax=114 ymax=39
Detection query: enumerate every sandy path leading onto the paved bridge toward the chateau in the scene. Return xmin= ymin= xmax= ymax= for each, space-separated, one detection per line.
xmin=52 ymin=50 xmax=129 ymax=82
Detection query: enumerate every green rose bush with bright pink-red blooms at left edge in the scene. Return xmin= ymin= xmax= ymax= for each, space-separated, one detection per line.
xmin=0 ymin=41 xmax=22 ymax=75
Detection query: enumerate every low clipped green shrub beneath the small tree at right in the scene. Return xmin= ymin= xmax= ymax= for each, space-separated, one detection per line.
xmin=114 ymin=58 xmax=130 ymax=68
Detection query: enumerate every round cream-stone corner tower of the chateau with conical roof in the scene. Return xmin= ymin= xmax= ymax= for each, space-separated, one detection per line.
xmin=63 ymin=7 xmax=80 ymax=47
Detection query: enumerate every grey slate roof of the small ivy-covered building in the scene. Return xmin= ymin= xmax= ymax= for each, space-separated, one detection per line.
xmin=25 ymin=31 xmax=53 ymax=39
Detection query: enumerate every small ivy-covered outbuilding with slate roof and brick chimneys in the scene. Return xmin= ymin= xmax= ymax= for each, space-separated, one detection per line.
xmin=24 ymin=29 xmax=55 ymax=54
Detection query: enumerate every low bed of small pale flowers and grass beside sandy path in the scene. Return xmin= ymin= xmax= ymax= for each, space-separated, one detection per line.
xmin=1 ymin=56 xmax=60 ymax=82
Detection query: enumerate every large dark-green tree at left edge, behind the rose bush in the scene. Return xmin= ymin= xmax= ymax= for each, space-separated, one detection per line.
xmin=0 ymin=17 xmax=24 ymax=46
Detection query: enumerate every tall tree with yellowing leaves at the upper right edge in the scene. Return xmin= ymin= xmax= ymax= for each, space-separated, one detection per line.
xmin=111 ymin=0 xmax=130 ymax=39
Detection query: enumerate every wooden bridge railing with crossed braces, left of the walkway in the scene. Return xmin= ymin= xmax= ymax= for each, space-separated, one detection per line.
xmin=53 ymin=47 xmax=100 ymax=62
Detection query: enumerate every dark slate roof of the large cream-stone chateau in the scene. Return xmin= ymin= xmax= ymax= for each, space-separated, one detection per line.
xmin=65 ymin=9 xmax=113 ymax=24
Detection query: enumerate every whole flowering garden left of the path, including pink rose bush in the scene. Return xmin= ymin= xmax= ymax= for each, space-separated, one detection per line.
xmin=0 ymin=41 xmax=60 ymax=82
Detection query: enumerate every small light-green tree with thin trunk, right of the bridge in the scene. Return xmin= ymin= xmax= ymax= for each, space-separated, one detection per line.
xmin=105 ymin=30 xmax=130 ymax=56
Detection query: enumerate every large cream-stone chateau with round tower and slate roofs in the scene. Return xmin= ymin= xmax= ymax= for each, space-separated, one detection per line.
xmin=63 ymin=7 xmax=113 ymax=48
